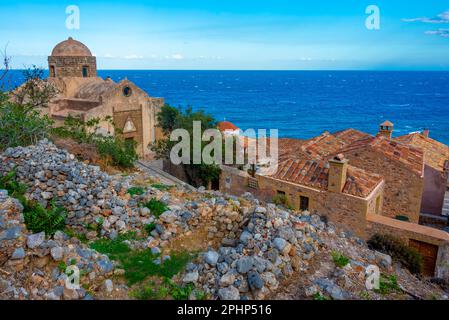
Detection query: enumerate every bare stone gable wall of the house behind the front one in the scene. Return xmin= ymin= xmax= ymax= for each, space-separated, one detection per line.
xmin=345 ymin=149 xmax=424 ymax=223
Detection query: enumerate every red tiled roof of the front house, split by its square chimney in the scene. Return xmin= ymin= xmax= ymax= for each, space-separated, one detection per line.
xmin=271 ymin=159 xmax=382 ymax=198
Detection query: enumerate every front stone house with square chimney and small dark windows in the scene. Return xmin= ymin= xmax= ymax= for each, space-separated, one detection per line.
xmin=220 ymin=156 xmax=384 ymax=238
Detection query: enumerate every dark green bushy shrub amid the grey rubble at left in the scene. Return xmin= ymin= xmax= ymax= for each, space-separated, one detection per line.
xmin=23 ymin=203 xmax=67 ymax=236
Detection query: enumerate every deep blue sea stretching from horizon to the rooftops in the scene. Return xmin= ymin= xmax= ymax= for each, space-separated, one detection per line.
xmin=5 ymin=70 xmax=449 ymax=145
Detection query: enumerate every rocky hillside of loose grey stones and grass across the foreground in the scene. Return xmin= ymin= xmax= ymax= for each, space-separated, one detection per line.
xmin=0 ymin=141 xmax=447 ymax=300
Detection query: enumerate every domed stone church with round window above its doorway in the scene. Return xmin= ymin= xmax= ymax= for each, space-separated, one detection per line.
xmin=48 ymin=38 xmax=164 ymax=157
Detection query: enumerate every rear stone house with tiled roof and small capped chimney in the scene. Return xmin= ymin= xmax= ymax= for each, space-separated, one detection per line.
xmin=279 ymin=121 xmax=424 ymax=223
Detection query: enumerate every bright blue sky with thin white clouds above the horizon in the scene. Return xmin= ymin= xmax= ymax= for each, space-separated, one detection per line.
xmin=0 ymin=0 xmax=449 ymax=70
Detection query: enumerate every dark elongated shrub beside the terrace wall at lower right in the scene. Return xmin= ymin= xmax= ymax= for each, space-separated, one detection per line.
xmin=368 ymin=234 xmax=423 ymax=274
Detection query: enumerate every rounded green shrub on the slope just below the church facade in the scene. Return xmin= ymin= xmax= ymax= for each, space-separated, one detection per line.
xmin=96 ymin=137 xmax=138 ymax=168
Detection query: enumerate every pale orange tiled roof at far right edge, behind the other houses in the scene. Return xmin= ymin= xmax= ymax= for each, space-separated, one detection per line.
xmin=394 ymin=132 xmax=449 ymax=171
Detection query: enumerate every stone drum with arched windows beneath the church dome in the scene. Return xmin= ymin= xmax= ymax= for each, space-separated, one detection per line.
xmin=48 ymin=56 xmax=97 ymax=78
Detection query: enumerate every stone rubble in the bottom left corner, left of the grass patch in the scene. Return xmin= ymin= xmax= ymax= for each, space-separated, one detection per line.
xmin=0 ymin=190 xmax=119 ymax=300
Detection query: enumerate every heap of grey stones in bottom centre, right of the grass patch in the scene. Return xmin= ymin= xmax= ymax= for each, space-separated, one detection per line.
xmin=183 ymin=200 xmax=326 ymax=299
